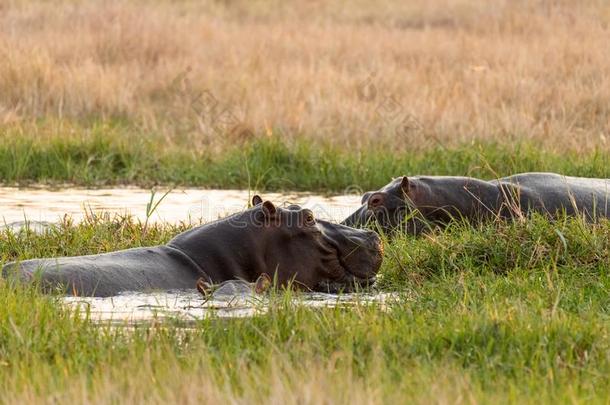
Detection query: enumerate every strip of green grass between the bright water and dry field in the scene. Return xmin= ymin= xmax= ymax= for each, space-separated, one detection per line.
xmin=0 ymin=123 xmax=610 ymax=192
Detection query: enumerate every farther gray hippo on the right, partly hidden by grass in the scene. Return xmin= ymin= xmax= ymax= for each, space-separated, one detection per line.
xmin=342 ymin=173 xmax=610 ymax=234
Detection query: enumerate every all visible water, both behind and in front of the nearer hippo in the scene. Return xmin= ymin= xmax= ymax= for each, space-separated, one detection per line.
xmin=0 ymin=187 xmax=384 ymax=323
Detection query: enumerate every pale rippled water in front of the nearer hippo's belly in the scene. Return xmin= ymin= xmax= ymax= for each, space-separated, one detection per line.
xmin=62 ymin=282 xmax=398 ymax=324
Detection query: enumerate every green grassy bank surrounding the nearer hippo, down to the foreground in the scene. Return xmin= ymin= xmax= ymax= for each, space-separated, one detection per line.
xmin=0 ymin=218 xmax=610 ymax=404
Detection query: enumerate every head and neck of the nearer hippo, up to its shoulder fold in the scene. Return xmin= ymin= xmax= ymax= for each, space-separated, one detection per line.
xmin=169 ymin=196 xmax=383 ymax=291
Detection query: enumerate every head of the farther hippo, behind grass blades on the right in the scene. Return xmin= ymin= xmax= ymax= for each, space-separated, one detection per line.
xmin=342 ymin=176 xmax=425 ymax=234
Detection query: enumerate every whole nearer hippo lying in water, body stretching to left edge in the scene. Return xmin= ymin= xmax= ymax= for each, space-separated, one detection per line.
xmin=2 ymin=196 xmax=383 ymax=297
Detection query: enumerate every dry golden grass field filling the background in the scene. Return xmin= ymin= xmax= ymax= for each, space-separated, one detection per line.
xmin=0 ymin=0 xmax=610 ymax=150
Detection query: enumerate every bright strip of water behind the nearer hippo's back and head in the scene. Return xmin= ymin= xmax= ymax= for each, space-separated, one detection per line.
xmin=0 ymin=187 xmax=360 ymax=227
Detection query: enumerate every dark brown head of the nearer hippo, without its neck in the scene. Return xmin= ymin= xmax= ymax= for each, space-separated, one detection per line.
xmin=252 ymin=196 xmax=383 ymax=292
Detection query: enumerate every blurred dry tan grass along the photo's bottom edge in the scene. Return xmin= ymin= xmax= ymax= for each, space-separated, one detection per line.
xmin=3 ymin=359 xmax=494 ymax=405
